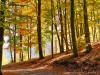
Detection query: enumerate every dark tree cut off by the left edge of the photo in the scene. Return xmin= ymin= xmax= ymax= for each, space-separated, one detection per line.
xmin=0 ymin=0 xmax=6 ymax=75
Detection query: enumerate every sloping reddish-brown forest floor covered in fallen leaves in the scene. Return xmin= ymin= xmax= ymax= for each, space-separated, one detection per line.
xmin=2 ymin=42 xmax=100 ymax=75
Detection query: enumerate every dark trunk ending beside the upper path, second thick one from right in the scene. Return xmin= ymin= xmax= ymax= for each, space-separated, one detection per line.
xmin=70 ymin=0 xmax=78 ymax=57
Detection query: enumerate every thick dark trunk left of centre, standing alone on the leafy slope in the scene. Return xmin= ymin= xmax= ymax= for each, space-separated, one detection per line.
xmin=37 ymin=0 xmax=43 ymax=59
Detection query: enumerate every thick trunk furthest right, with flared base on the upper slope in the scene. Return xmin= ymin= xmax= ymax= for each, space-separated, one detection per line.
xmin=83 ymin=0 xmax=92 ymax=53
